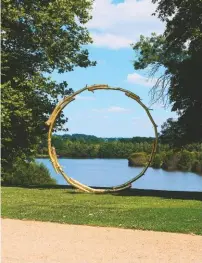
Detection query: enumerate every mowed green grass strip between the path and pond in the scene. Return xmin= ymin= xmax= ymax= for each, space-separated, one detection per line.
xmin=1 ymin=187 xmax=202 ymax=235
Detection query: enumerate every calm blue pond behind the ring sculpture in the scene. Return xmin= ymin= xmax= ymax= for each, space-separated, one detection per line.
xmin=36 ymin=158 xmax=202 ymax=192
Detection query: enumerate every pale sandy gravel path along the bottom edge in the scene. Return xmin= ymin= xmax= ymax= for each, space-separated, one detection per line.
xmin=2 ymin=219 xmax=202 ymax=263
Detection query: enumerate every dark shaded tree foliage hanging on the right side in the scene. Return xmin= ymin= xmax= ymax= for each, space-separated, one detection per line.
xmin=133 ymin=0 xmax=202 ymax=147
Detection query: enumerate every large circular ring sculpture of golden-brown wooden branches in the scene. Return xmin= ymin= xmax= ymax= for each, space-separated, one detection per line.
xmin=46 ymin=84 xmax=158 ymax=193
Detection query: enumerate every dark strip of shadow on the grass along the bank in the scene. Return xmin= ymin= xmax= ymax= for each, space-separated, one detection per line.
xmin=2 ymin=185 xmax=202 ymax=201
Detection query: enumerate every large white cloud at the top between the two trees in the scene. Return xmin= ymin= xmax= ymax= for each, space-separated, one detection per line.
xmin=87 ymin=0 xmax=164 ymax=49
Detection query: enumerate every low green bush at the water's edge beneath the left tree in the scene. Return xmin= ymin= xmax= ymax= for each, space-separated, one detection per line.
xmin=2 ymin=160 xmax=56 ymax=185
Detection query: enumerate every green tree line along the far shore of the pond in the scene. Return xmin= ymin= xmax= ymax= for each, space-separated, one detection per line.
xmin=38 ymin=134 xmax=202 ymax=173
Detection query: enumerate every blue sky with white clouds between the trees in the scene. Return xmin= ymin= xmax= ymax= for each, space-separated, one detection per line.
xmin=52 ymin=0 xmax=176 ymax=137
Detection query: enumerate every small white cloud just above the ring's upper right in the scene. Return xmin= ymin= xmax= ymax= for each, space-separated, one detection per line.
xmin=127 ymin=73 xmax=157 ymax=87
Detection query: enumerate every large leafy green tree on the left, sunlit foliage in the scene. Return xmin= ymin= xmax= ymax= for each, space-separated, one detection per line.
xmin=1 ymin=0 xmax=95 ymax=172
